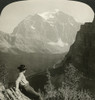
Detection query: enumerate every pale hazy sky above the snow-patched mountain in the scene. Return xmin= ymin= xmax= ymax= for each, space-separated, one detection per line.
xmin=0 ymin=0 xmax=94 ymax=33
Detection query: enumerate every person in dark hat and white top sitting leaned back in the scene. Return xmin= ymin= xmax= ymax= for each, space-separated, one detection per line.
xmin=16 ymin=65 xmax=42 ymax=100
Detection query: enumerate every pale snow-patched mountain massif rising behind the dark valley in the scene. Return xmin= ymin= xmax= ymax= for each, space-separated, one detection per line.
xmin=0 ymin=10 xmax=80 ymax=54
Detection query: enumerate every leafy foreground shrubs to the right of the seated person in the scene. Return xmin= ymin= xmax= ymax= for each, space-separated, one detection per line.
xmin=43 ymin=64 xmax=94 ymax=100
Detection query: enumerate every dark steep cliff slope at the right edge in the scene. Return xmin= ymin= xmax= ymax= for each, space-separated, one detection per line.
xmin=65 ymin=17 xmax=95 ymax=78
